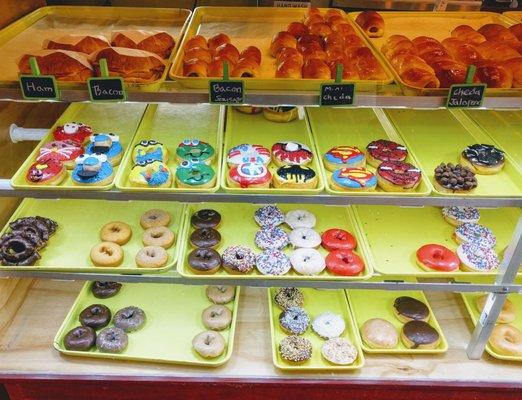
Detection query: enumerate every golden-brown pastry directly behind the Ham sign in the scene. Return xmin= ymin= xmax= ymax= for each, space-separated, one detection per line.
xmin=18 ymin=50 xmax=93 ymax=82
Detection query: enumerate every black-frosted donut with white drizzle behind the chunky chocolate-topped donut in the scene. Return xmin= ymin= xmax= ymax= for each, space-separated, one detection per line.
xmin=460 ymin=144 xmax=505 ymax=175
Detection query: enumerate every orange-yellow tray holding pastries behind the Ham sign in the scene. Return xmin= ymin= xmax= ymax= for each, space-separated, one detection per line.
xmin=0 ymin=6 xmax=191 ymax=92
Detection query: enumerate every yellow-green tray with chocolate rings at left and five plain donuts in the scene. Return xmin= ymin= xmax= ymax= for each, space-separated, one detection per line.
xmin=0 ymin=199 xmax=185 ymax=274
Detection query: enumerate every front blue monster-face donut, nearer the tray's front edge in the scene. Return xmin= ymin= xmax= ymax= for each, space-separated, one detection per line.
xmin=71 ymin=154 xmax=114 ymax=186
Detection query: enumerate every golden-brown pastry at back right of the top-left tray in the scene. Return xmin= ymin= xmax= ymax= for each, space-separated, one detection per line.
xmin=111 ymin=29 xmax=176 ymax=59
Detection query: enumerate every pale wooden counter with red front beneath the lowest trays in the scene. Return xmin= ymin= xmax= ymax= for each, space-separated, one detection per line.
xmin=0 ymin=280 xmax=522 ymax=400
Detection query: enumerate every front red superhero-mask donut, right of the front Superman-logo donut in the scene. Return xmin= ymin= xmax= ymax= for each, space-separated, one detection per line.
xmin=377 ymin=161 xmax=421 ymax=192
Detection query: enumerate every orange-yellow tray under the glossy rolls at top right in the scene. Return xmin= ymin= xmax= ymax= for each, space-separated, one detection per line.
xmin=348 ymin=11 xmax=522 ymax=96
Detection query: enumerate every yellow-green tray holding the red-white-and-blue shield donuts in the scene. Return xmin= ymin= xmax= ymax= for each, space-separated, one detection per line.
xmin=221 ymin=107 xmax=324 ymax=194
